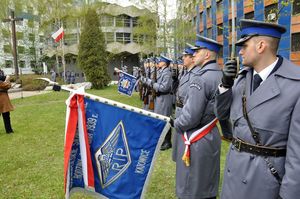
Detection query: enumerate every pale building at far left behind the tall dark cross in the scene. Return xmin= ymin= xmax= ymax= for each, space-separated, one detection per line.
xmin=0 ymin=6 xmax=44 ymax=74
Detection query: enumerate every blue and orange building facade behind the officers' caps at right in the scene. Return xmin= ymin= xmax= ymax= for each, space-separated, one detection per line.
xmin=195 ymin=0 xmax=300 ymax=65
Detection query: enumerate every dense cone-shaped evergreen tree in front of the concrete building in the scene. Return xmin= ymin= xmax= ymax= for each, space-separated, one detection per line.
xmin=78 ymin=8 xmax=110 ymax=89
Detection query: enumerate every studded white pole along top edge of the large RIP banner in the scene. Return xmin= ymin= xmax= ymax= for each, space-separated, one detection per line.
xmin=61 ymin=86 xmax=170 ymax=122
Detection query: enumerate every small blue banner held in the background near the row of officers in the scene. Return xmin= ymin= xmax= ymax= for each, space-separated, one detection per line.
xmin=118 ymin=72 xmax=137 ymax=96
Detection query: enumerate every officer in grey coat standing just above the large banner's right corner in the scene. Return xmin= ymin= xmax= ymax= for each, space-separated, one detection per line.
xmin=145 ymin=56 xmax=172 ymax=150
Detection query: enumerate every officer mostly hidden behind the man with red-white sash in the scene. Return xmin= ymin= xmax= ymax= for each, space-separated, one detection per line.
xmin=172 ymin=44 xmax=196 ymax=162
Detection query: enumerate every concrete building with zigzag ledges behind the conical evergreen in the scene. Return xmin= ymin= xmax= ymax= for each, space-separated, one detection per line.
xmin=46 ymin=3 xmax=157 ymax=80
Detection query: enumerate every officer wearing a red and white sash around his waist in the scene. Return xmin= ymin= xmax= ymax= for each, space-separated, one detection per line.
xmin=174 ymin=35 xmax=222 ymax=199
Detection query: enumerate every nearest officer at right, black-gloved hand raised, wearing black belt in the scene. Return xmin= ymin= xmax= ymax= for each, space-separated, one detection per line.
xmin=215 ymin=20 xmax=300 ymax=199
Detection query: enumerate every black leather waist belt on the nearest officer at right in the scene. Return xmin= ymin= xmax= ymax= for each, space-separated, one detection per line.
xmin=232 ymin=138 xmax=286 ymax=157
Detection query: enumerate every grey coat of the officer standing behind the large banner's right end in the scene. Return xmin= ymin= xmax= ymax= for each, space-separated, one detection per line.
xmin=153 ymin=67 xmax=172 ymax=116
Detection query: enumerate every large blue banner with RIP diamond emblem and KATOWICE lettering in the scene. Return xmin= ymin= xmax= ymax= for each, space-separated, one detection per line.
xmin=67 ymin=95 xmax=169 ymax=199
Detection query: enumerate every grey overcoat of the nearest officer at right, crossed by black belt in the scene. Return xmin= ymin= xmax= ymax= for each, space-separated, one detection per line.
xmin=215 ymin=57 xmax=300 ymax=199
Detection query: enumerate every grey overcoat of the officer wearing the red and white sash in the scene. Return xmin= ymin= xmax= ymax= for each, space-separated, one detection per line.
xmin=174 ymin=62 xmax=222 ymax=199
